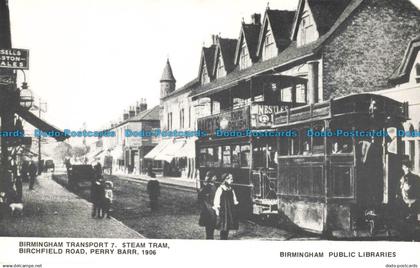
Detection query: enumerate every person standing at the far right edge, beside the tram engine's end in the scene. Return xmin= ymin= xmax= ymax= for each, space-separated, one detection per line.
xmin=400 ymin=159 xmax=420 ymax=221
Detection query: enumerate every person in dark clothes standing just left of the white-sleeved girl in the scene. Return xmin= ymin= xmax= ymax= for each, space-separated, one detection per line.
xmin=198 ymin=171 xmax=217 ymax=239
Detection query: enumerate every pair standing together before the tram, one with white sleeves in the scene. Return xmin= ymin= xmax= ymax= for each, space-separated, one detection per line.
xmin=198 ymin=171 xmax=239 ymax=240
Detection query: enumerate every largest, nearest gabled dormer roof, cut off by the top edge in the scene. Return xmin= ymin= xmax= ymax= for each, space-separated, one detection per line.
xmin=291 ymin=0 xmax=351 ymax=40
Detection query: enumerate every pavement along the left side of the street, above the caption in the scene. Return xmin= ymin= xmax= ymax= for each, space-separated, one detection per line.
xmin=0 ymin=174 xmax=144 ymax=238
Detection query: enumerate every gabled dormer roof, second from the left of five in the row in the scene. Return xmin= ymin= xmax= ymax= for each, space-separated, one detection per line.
xmin=213 ymin=37 xmax=238 ymax=75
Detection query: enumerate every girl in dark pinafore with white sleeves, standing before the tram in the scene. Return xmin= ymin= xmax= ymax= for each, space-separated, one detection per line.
xmin=213 ymin=173 xmax=239 ymax=240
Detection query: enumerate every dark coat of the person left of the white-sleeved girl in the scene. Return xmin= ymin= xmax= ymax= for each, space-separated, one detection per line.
xmin=198 ymin=184 xmax=217 ymax=228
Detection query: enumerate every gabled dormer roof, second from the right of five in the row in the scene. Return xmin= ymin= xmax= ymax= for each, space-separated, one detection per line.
xmin=258 ymin=9 xmax=295 ymax=53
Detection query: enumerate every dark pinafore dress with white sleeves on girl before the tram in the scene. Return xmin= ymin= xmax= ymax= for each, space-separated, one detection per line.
xmin=214 ymin=185 xmax=239 ymax=231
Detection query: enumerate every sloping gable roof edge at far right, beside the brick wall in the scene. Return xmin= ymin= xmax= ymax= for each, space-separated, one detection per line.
xmin=389 ymin=35 xmax=420 ymax=85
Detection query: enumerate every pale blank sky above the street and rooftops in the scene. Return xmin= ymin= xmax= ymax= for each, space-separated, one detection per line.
xmin=5 ymin=0 xmax=420 ymax=130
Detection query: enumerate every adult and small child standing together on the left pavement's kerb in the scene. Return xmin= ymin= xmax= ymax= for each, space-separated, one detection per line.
xmin=90 ymin=163 xmax=114 ymax=219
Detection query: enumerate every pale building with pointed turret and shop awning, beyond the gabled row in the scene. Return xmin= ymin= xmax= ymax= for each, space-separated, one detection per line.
xmin=146 ymin=59 xmax=198 ymax=178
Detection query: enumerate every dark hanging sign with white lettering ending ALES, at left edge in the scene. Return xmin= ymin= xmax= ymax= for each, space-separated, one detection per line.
xmin=0 ymin=48 xmax=29 ymax=70
